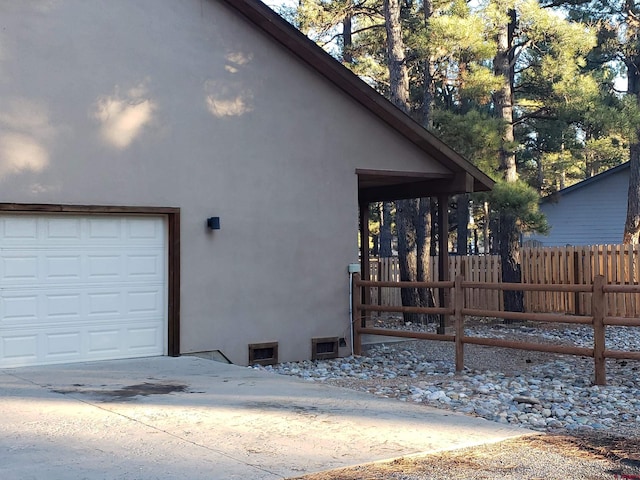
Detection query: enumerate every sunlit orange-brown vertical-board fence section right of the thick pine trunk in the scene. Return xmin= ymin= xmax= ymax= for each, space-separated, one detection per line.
xmin=521 ymin=245 xmax=640 ymax=317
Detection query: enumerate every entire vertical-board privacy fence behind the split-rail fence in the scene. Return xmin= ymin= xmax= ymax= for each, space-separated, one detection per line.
xmin=370 ymin=245 xmax=640 ymax=317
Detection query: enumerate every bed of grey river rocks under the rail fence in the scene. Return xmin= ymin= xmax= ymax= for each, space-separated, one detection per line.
xmin=253 ymin=320 xmax=640 ymax=437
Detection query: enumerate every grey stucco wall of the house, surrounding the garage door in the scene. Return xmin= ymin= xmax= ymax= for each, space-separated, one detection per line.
xmin=0 ymin=0 xmax=488 ymax=364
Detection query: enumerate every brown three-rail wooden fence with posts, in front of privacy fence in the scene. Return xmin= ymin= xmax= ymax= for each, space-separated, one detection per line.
xmin=352 ymin=274 xmax=640 ymax=385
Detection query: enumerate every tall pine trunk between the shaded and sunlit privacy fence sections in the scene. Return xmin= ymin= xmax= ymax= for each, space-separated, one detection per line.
xmin=493 ymin=9 xmax=524 ymax=312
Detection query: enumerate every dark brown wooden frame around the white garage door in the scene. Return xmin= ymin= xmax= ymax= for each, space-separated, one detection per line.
xmin=0 ymin=203 xmax=180 ymax=357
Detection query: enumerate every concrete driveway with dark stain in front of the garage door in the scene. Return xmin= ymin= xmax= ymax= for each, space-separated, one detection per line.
xmin=0 ymin=357 xmax=529 ymax=480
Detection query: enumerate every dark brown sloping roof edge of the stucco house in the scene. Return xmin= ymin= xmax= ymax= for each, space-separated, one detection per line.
xmin=221 ymin=0 xmax=495 ymax=196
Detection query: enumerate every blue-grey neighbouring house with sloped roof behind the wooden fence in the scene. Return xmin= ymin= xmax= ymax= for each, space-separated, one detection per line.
xmin=525 ymin=162 xmax=629 ymax=247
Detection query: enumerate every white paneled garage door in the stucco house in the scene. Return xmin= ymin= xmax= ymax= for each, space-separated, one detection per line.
xmin=0 ymin=214 xmax=167 ymax=368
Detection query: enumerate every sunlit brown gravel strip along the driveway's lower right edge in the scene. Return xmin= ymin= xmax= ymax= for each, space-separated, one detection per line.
xmin=292 ymin=435 xmax=640 ymax=480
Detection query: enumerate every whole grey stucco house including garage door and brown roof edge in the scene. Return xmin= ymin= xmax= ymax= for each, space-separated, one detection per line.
xmin=0 ymin=0 xmax=493 ymax=367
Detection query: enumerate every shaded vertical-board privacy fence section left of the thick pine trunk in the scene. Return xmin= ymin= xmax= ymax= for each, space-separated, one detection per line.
xmin=369 ymin=255 xmax=502 ymax=310
